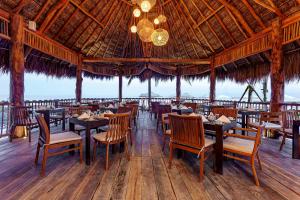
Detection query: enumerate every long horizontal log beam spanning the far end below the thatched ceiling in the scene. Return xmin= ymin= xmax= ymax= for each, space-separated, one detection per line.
xmin=83 ymin=57 xmax=210 ymax=65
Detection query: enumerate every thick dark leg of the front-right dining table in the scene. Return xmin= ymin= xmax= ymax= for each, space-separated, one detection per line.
xmin=214 ymin=126 xmax=223 ymax=174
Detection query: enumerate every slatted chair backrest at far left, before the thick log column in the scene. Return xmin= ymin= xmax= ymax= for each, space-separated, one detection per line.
xmin=12 ymin=106 xmax=31 ymax=126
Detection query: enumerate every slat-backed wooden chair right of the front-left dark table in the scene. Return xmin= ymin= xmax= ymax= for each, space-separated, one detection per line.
xmin=93 ymin=113 xmax=130 ymax=170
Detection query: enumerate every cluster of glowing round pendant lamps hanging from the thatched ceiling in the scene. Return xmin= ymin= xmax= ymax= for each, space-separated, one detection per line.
xmin=130 ymin=0 xmax=169 ymax=46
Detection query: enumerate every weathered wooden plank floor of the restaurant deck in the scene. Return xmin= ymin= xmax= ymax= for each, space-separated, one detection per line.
xmin=0 ymin=113 xmax=300 ymax=200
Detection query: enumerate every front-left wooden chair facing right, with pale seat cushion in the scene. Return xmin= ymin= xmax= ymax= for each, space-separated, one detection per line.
xmin=34 ymin=115 xmax=83 ymax=176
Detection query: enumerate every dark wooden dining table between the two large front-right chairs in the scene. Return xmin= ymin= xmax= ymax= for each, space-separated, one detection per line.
xmin=203 ymin=121 xmax=237 ymax=174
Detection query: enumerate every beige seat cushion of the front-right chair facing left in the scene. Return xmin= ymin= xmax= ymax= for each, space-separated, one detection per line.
xmin=223 ymin=137 xmax=254 ymax=154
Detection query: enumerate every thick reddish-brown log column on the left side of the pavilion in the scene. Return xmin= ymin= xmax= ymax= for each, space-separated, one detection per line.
xmin=9 ymin=13 xmax=25 ymax=105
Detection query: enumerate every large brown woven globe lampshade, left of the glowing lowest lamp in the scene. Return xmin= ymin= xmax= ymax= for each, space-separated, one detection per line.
xmin=137 ymin=19 xmax=154 ymax=42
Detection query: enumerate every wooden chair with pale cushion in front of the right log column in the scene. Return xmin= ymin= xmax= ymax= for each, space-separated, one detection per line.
xmin=248 ymin=112 xmax=282 ymax=136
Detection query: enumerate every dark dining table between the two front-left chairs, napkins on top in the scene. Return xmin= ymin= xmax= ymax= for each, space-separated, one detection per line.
xmin=69 ymin=117 xmax=109 ymax=165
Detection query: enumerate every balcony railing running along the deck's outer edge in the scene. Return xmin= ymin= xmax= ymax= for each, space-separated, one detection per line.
xmin=0 ymin=97 xmax=300 ymax=138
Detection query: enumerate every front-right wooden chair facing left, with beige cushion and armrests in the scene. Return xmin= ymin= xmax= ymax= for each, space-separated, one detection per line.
xmin=223 ymin=126 xmax=264 ymax=186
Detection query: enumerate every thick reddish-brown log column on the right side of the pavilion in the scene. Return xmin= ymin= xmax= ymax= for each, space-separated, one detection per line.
xmin=270 ymin=20 xmax=284 ymax=112
